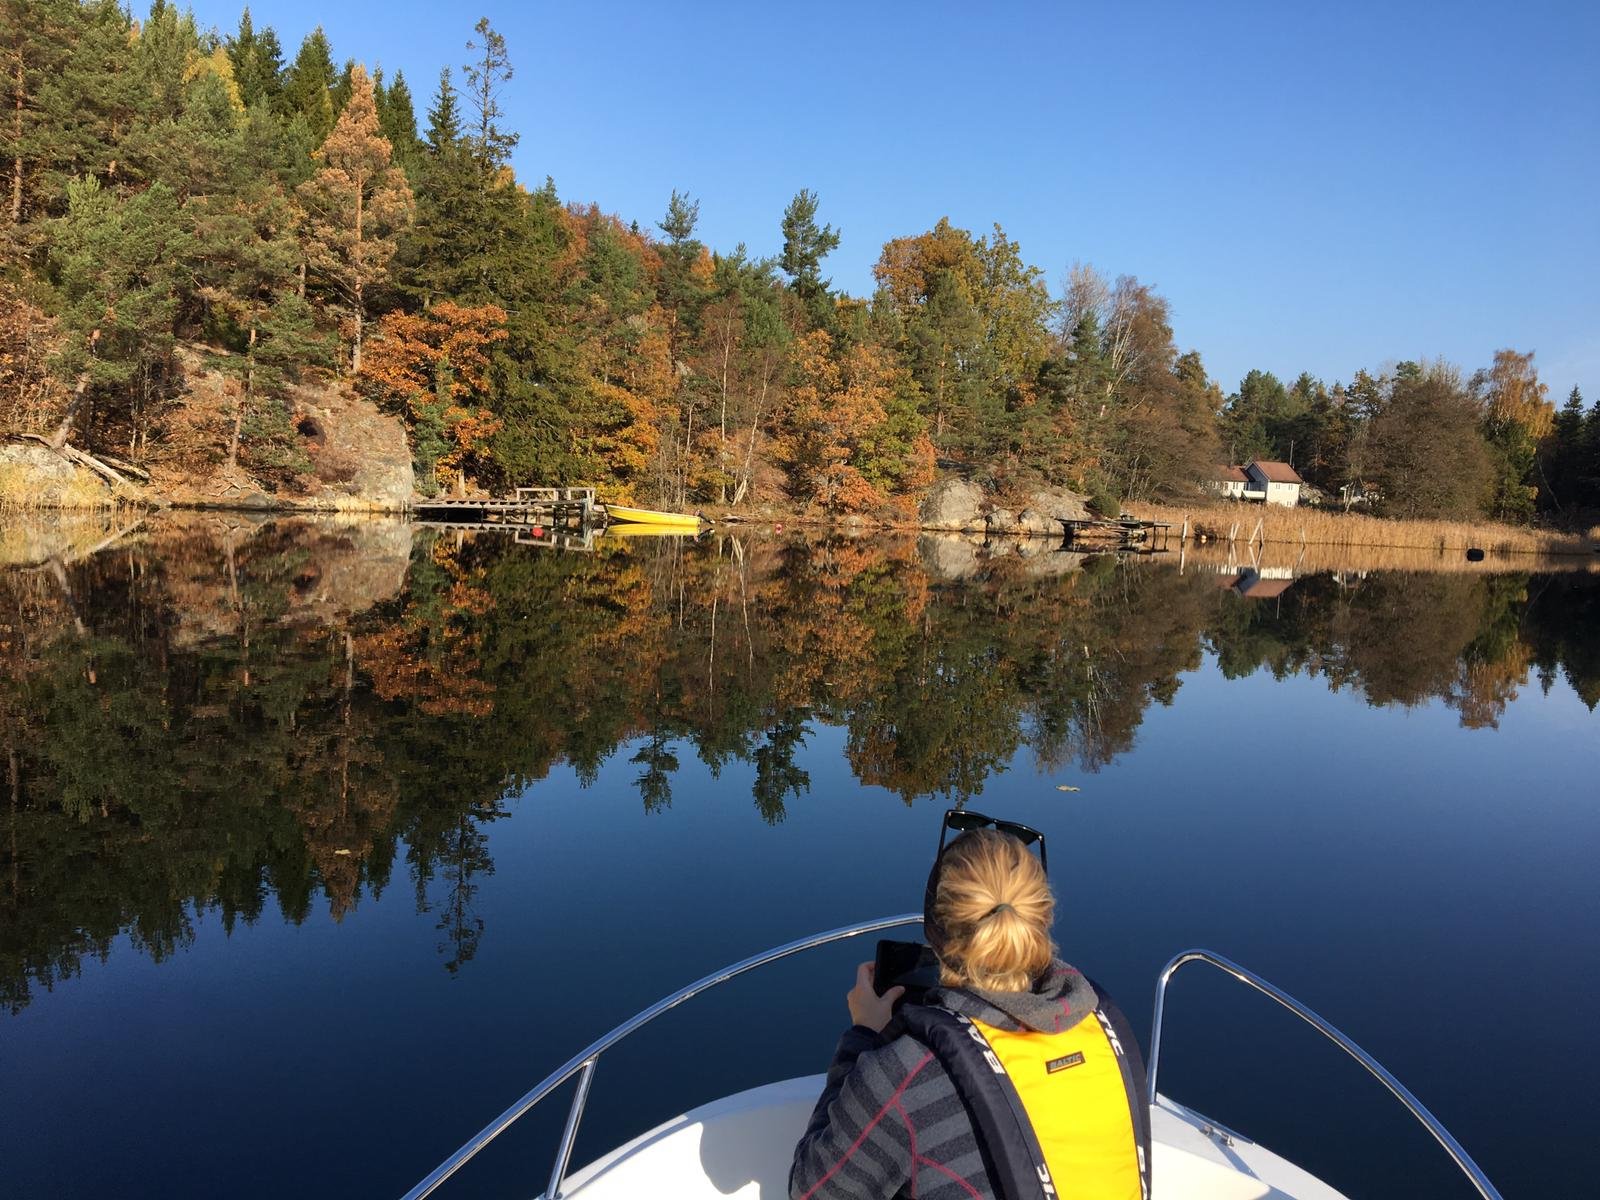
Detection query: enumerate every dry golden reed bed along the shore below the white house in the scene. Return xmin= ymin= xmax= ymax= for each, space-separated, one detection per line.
xmin=1128 ymin=504 xmax=1600 ymax=555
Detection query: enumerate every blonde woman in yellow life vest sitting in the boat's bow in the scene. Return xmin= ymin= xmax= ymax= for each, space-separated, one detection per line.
xmin=789 ymin=818 xmax=1149 ymax=1200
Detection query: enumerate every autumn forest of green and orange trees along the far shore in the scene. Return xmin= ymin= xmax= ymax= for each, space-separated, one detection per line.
xmin=0 ymin=0 xmax=1600 ymax=520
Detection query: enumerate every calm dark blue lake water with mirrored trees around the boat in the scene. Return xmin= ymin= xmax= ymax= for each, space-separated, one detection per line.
xmin=0 ymin=520 xmax=1600 ymax=1197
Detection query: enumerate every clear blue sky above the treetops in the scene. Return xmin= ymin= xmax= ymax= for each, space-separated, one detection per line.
xmin=181 ymin=0 xmax=1600 ymax=403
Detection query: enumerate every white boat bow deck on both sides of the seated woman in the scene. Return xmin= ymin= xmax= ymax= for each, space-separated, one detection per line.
xmin=562 ymin=1075 xmax=1346 ymax=1200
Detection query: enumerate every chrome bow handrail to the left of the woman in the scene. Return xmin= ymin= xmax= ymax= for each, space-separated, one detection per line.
xmin=403 ymin=912 xmax=922 ymax=1200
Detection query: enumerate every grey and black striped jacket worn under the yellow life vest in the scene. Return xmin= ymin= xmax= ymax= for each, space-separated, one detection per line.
xmin=789 ymin=962 xmax=1144 ymax=1200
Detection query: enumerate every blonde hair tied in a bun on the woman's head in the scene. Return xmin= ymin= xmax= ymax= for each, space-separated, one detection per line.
xmin=933 ymin=829 xmax=1056 ymax=992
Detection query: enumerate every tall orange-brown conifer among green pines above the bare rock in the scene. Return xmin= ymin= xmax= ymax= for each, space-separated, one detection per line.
xmin=299 ymin=66 xmax=411 ymax=373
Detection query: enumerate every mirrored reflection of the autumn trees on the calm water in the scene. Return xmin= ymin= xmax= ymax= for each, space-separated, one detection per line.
xmin=0 ymin=525 xmax=1600 ymax=1008
